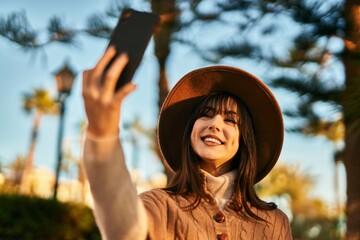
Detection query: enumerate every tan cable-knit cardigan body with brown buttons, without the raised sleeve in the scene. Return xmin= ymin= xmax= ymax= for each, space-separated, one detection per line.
xmin=140 ymin=190 xmax=292 ymax=240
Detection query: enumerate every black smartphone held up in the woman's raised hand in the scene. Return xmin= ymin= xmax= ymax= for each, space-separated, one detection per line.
xmin=108 ymin=8 xmax=160 ymax=90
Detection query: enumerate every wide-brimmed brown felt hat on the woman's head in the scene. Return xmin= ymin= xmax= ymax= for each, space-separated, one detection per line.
xmin=158 ymin=66 xmax=284 ymax=182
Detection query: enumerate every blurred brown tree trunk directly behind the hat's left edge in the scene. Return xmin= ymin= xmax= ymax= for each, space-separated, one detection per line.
xmin=151 ymin=0 xmax=178 ymax=180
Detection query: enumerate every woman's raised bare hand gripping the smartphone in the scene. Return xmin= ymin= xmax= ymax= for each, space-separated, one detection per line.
xmin=82 ymin=46 xmax=136 ymax=138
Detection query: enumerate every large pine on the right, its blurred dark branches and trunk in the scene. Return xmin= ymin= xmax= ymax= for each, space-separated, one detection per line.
xmin=175 ymin=0 xmax=360 ymax=236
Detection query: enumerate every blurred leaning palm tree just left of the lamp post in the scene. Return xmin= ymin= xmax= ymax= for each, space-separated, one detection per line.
xmin=19 ymin=88 xmax=58 ymax=191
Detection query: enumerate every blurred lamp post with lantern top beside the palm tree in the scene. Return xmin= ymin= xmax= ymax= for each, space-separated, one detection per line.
xmin=53 ymin=63 xmax=75 ymax=199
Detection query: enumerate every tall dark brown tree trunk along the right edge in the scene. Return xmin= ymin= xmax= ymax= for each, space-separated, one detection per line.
xmin=343 ymin=0 xmax=360 ymax=239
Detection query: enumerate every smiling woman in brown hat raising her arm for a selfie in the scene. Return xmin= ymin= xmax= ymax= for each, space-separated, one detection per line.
xmin=83 ymin=47 xmax=292 ymax=239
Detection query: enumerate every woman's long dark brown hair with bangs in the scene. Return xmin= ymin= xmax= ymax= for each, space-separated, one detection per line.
xmin=165 ymin=92 xmax=277 ymax=220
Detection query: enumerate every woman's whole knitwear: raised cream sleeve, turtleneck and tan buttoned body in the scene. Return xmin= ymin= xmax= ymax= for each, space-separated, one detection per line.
xmin=84 ymin=138 xmax=292 ymax=240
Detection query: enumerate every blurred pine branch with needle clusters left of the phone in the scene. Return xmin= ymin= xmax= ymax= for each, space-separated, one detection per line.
xmin=0 ymin=4 xmax=127 ymax=51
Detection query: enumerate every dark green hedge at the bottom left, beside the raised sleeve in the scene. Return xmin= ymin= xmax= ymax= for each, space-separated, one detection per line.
xmin=0 ymin=195 xmax=101 ymax=240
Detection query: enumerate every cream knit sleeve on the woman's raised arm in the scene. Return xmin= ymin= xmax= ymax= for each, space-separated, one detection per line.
xmin=84 ymin=137 xmax=147 ymax=240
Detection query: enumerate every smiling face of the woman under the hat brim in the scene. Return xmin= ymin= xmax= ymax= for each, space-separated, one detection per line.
xmin=191 ymin=101 xmax=240 ymax=170
